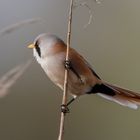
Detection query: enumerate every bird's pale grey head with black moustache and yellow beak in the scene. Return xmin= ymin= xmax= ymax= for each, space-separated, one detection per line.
xmin=28 ymin=33 xmax=66 ymax=60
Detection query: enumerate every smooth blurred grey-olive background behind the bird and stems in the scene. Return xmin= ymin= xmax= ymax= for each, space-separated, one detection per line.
xmin=0 ymin=0 xmax=140 ymax=140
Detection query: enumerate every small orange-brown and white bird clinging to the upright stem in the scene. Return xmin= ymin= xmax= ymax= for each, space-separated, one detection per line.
xmin=28 ymin=33 xmax=140 ymax=109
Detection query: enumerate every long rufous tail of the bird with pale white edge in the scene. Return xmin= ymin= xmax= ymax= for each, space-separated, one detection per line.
xmin=97 ymin=82 xmax=140 ymax=109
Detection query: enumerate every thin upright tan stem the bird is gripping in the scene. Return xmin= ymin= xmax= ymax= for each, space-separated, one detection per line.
xmin=58 ymin=0 xmax=74 ymax=140
